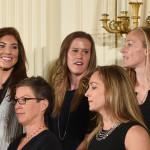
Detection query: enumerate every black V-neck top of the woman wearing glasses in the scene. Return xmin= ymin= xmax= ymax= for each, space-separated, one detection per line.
xmin=7 ymin=130 xmax=62 ymax=150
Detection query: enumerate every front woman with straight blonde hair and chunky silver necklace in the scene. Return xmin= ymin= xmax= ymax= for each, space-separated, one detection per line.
xmin=85 ymin=65 xmax=150 ymax=150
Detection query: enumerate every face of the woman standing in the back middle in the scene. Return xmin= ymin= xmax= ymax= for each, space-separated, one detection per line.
xmin=67 ymin=38 xmax=91 ymax=76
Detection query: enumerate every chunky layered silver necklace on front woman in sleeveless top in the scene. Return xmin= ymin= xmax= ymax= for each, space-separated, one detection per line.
xmin=96 ymin=123 xmax=120 ymax=141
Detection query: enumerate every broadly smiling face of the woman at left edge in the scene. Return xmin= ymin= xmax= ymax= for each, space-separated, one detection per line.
xmin=0 ymin=35 xmax=19 ymax=70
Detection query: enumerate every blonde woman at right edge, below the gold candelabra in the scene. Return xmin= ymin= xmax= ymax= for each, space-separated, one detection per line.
xmin=121 ymin=27 xmax=150 ymax=132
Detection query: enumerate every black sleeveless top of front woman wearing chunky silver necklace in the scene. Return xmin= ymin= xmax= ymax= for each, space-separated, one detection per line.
xmin=88 ymin=122 xmax=140 ymax=150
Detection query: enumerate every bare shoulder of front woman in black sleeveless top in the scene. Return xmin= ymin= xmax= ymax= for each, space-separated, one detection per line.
xmin=125 ymin=125 xmax=150 ymax=150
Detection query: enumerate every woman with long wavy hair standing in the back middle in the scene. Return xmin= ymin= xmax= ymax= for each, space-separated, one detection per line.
xmin=50 ymin=31 xmax=96 ymax=150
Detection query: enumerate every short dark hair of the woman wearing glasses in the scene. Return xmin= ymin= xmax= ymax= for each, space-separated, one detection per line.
xmin=16 ymin=76 xmax=54 ymax=110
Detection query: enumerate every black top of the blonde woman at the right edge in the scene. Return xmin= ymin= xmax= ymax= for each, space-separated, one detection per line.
xmin=140 ymin=90 xmax=150 ymax=133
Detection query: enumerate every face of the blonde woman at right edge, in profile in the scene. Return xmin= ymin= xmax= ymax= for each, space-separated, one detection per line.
xmin=121 ymin=30 xmax=146 ymax=69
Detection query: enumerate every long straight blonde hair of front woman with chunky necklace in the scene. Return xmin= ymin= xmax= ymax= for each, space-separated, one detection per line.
xmin=88 ymin=65 xmax=146 ymax=143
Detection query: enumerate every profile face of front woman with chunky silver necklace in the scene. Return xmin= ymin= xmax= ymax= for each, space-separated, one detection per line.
xmin=85 ymin=71 xmax=105 ymax=113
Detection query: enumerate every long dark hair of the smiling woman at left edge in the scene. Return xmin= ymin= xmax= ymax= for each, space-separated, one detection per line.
xmin=0 ymin=27 xmax=27 ymax=99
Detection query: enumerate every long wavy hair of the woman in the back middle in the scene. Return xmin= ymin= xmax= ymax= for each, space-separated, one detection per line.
xmin=52 ymin=31 xmax=96 ymax=117
